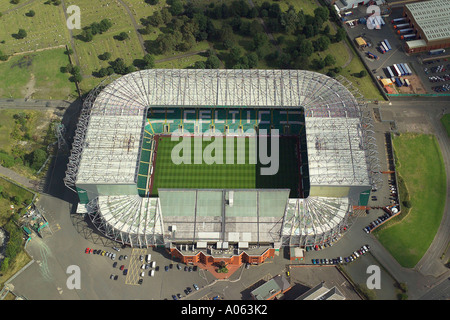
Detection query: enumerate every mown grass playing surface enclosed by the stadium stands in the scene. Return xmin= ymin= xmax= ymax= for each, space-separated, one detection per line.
xmin=151 ymin=136 xmax=300 ymax=196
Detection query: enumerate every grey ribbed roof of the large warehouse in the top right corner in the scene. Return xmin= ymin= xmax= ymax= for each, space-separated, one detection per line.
xmin=405 ymin=0 xmax=450 ymax=41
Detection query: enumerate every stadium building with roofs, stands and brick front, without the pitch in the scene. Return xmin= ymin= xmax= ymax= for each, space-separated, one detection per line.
xmin=64 ymin=69 xmax=381 ymax=265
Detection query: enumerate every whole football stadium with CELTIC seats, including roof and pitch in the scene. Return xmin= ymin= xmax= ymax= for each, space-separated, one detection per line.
xmin=64 ymin=69 xmax=381 ymax=264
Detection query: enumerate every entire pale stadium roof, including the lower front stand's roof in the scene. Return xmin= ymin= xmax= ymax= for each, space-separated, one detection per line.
xmin=64 ymin=69 xmax=376 ymax=246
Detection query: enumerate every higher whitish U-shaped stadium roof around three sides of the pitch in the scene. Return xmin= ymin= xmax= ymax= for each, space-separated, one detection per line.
xmin=69 ymin=69 xmax=367 ymax=185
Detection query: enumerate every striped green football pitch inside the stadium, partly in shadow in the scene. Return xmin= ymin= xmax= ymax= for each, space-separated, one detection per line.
xmin=150 ymin=136 xmax=301 ymax=196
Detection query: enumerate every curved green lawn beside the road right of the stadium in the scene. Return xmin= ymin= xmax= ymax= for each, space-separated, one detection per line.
xmin=375 ymin=133 xmax=446 ymax=268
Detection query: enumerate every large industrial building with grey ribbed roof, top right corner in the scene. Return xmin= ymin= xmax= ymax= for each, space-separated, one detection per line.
xmin=403 ymin=0 xmax=450 ymax=53
